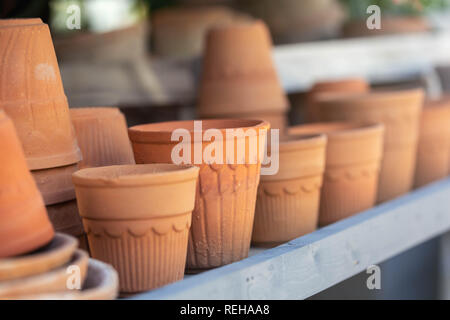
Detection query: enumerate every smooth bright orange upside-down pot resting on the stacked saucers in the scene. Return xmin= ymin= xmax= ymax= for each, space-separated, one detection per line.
xmin=0 ymin=110 xmax=54 ymax=258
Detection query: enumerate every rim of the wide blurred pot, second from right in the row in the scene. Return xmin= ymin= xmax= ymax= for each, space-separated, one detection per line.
xmin=315 ymin=88 xmax=425 ymax=108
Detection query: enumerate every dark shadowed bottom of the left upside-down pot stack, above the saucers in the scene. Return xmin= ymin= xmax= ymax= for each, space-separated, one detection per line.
xmin=47 ymin=200 xmax=89 ymax=252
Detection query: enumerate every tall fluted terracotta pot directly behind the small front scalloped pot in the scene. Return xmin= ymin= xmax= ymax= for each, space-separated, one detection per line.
xmin=129 ymin=119 xmax=269 ymax=272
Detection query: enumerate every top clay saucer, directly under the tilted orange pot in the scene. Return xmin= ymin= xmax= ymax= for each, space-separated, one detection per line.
xmin=0 ymin=233 xmax=78 ymax=281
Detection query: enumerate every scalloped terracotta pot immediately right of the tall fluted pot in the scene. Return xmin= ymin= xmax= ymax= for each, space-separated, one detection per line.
xmin=252 ymin=135 xmax=327 ymax=246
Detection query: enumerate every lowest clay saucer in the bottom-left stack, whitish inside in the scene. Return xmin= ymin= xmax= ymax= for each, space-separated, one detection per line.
xmin=13 ymin=259 xmax=119 ymax=300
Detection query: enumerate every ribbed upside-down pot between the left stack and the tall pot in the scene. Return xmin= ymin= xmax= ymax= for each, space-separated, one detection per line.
xmin=70 ymin=107 xmax=135 ymax=168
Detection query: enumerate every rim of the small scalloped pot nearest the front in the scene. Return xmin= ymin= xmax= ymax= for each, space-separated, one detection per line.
xmin=72 ymin=163 xmax=199 ymax=188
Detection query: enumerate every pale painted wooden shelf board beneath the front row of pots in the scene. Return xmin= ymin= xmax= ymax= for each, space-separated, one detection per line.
xmin=133 ymin=178 xmax=450 ymax=299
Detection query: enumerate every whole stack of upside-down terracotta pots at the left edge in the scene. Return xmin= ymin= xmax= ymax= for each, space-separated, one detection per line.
xmin=0 ymin=19 xmax=86 ymax=246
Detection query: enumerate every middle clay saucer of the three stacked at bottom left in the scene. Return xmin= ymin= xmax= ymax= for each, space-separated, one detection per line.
xmin=0 ymin=250 xmax=89 ymax=299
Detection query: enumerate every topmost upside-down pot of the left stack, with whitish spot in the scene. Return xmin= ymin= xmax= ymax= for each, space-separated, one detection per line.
xmin=0 ymin=24 xmax=81 ymax=170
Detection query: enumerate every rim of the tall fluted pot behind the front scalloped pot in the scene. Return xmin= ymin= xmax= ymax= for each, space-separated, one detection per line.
xmin=128 ymin=118 xmax=270 ymax=143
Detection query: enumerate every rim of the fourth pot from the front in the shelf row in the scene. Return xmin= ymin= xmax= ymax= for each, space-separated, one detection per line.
xmin=288 ymin=121 xmax=384 ymax=140
